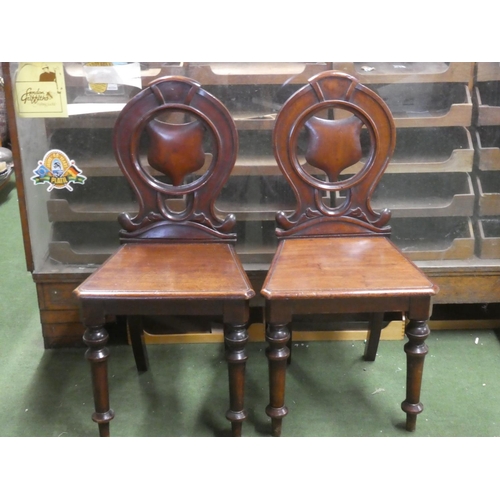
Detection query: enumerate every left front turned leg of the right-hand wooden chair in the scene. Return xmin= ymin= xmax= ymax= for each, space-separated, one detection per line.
xmin=266 ymin=324 xmax=290 ymax=437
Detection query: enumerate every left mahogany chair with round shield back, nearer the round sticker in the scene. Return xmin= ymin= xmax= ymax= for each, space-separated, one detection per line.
xmin=75 ymin=77 xmax=255 ymax=436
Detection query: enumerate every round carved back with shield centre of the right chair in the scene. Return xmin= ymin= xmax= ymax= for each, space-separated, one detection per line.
xmin=273 ymin=71 xmax=396 ymax=239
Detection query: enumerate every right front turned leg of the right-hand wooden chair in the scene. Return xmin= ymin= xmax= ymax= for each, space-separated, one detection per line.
xmin=401 ymin=320 xmax=430 ymax=431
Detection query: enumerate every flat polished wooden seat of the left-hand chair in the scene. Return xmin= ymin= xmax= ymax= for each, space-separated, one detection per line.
xmin=76 ymin=243 xmax=254 ymax=300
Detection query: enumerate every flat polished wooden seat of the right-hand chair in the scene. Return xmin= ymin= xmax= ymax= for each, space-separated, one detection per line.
xmin=262 ymin=236 xmax=436 ymax=300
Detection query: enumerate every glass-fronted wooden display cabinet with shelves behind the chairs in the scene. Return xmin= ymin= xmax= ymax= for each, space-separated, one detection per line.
xmin=2 ymin=62 xmax=500 ymax=348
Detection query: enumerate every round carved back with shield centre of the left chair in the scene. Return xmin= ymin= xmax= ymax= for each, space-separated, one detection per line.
xmin=113 ymin=76 xmax=238 ymax=243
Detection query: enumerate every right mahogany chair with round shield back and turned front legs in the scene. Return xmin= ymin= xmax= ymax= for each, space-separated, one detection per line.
xmin=261 ymin=71 xmax=438 ymax=436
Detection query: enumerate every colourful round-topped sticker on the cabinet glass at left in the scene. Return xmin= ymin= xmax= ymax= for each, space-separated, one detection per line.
xmin=31 ymin=149 xmax=87 ymax=192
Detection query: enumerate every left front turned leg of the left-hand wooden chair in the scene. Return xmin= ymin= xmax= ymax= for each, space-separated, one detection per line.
xmin=83 ymin=326 xmax=115 ymax=437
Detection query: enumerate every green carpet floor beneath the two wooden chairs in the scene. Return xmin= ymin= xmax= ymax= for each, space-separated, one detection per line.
xmin=0 ymin=179 xmax=500 ymax=438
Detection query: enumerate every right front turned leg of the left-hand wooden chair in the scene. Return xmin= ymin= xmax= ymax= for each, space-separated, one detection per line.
xmin=224 ymin=325 xmax=248 ymax=437
